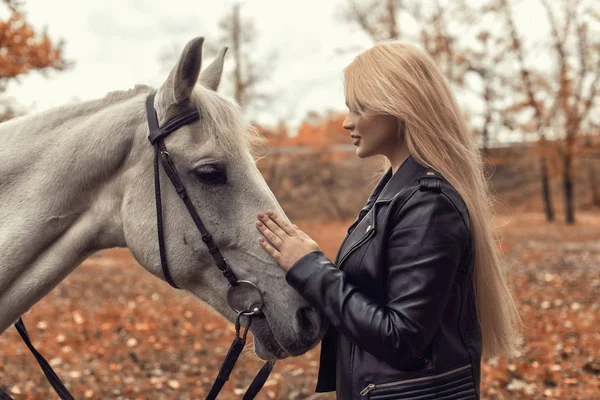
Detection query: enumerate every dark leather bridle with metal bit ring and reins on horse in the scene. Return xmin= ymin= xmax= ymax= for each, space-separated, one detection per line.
xmin=0 ymin=90 xmax=275 ymax=400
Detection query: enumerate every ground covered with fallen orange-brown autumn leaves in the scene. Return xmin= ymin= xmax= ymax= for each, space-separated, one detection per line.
xmin=0 ymin=213 xmax=600 ymax=400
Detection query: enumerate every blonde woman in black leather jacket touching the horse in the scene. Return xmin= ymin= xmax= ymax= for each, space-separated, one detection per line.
xmin=256 ymin=42 xmax=520 ymax=400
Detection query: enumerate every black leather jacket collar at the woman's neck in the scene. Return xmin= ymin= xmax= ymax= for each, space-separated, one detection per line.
xmin=364 ymin=155 xmax=427 ymax=209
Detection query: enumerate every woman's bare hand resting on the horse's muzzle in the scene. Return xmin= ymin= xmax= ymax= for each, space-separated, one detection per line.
xmin=256 ymin=210 xmax=320 ymax=271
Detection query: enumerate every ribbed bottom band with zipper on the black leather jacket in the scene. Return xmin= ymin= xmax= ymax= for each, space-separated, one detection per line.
xmin=360 ymin=364 xmax=477 ymax=400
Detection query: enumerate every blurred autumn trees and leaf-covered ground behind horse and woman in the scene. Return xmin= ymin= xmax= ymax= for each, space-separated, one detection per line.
xmin=0 ymin=0 xmax=600 ymax=399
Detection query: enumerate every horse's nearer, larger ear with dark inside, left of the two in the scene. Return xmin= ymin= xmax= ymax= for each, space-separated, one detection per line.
xmin=162 ymin=37 xmax=204 ymax=103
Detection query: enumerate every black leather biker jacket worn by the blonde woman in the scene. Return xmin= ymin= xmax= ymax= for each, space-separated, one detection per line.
xmin=286 ymin=156 xmax=481 ymax=400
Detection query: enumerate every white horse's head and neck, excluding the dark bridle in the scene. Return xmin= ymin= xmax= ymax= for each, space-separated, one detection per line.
xmin=0 ymin=38 xmax=324 ymax=360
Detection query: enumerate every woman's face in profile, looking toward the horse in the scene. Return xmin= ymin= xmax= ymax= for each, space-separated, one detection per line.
xmin=343 ymin=106 xmax=400 ymax=158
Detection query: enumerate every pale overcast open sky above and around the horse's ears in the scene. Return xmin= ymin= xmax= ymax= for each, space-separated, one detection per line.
xmin=7 ymin=0 xmax=541 ymax=133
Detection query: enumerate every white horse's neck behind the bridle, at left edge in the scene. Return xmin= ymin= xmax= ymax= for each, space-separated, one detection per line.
xmin=0 ymin=92 xmax=145 ymax=333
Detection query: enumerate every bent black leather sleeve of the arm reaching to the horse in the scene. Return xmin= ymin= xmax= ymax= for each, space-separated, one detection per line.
xmin=286 ymin=191 xmax=469 ymax=367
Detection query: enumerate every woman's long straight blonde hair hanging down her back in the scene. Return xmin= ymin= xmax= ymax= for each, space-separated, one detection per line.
xmin=344 ymin=41 xmax=522 ymax=357
